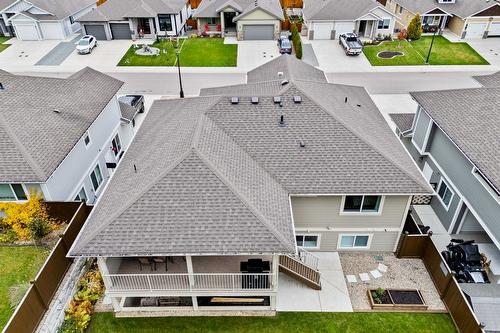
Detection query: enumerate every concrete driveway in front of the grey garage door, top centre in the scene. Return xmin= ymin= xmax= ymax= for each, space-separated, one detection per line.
xmin=238 ymin=40 xmax=280 ymax=71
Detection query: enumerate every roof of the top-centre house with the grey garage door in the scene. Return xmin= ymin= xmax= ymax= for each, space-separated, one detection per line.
xmin=193 ymin=0 xmax=285 ymax=21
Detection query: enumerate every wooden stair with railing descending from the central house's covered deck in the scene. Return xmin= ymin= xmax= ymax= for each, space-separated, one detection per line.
xmin=279 ymin=249 xmax=321 ymax=290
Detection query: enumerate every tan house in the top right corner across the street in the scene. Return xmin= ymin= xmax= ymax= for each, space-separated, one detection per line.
xmin=385 ymin=0 xmax=500 ymax=38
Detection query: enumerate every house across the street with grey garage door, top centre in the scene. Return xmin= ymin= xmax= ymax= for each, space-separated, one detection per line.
xmin=193 ymin=0 xmax=285 ymax=40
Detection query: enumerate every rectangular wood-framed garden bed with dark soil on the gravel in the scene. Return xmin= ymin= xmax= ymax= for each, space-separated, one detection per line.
xmin=368 ymin=288 xmax=428 ymax=311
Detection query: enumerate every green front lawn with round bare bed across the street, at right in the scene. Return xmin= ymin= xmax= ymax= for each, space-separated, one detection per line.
xmin=363 ymin=36 xmax=488 ymax=66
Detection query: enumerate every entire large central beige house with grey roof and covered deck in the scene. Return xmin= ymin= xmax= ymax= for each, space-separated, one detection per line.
xmin=69 ymin=56 xmax=432 ymax=315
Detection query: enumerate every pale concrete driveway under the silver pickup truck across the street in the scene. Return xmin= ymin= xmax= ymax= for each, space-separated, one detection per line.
xmin=302 ymin=39 xmax=371 ymax=73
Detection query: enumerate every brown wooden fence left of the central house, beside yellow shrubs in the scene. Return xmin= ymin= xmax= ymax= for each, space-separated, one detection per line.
xmin=3 ymin=202 xmax=92 ymax=333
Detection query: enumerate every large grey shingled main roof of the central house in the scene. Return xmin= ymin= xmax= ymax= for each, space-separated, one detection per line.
xmin=70 ymin=55 xmax=432 ymax=256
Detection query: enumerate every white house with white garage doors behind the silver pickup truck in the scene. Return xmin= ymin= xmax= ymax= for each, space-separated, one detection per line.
xmin=303 ymin=0 xmax=395 ymax=39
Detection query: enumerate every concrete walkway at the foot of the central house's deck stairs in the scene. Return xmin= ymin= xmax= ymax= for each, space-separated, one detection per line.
xmin=276 ymin=252 xmax=352 ymax=312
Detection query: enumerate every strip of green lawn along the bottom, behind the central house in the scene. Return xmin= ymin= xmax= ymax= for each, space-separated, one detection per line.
xmin=86 ymin=312 xmax=456 ymax=333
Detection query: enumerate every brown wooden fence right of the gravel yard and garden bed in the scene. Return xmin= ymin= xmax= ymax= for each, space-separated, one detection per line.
xmin=396 ymin=234 xmax=483 ymax=333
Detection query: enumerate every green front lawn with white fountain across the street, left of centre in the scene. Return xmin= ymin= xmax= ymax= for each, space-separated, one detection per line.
xmin=118 ymin=38 xmax=238 ymax=67
